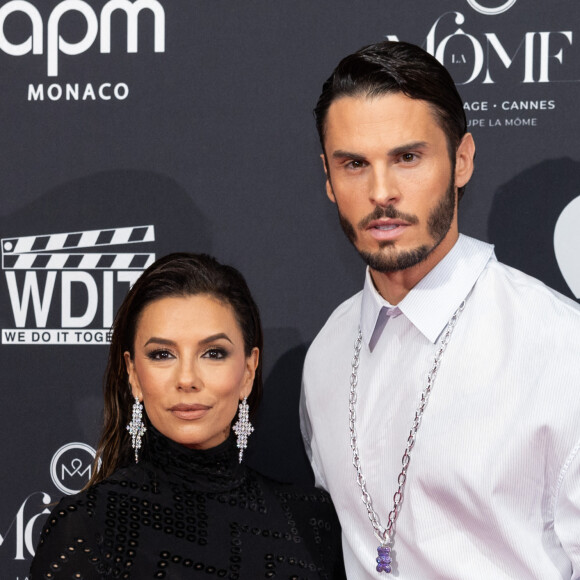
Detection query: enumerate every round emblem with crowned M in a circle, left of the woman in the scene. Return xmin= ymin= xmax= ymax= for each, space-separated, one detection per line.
xmin=50 ymin=443 xmax=96 ymax=495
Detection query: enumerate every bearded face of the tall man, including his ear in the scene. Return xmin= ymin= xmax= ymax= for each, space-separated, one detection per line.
xmin=324 ymin=93 xmax=473 ymax=272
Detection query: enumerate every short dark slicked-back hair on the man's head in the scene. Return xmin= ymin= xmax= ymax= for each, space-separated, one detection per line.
xmin=314 ymin=41 xmax=467 ymax=198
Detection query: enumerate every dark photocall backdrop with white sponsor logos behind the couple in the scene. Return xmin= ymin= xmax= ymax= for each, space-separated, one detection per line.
xmin=0 ymin=0 xmax=580 ymax=580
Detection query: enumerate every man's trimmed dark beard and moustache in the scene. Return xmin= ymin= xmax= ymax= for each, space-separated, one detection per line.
xmin=337 ymin=172 xmax=455 ymax=273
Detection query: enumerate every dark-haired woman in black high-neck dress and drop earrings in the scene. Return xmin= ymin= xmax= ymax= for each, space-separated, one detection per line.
xmin=31 ymin=254 xmax=344 ymax=580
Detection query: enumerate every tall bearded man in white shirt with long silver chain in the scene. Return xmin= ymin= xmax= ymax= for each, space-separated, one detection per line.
xmin=301 ymin=42 xmax=580 ymax=580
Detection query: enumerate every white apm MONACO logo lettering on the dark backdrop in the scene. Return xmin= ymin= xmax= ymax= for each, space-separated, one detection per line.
xmin=0 ymin=0 xmax=165 ymax=101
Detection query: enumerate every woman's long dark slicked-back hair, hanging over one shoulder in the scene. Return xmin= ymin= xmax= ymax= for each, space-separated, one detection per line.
xmin=86 ymin=253 xmax=263 ymax=487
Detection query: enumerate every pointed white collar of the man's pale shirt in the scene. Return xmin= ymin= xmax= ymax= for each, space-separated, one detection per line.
xmin=360 ymin=234 xmax=495 ymax=345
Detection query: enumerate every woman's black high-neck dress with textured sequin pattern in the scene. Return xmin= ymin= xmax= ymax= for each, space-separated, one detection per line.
xmin=31 ymin=427 xmax=345 ymax=580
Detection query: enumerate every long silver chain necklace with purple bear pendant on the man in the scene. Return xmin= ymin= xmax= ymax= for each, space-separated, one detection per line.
xmin=348 ymin=300 xmax=465 ymax=574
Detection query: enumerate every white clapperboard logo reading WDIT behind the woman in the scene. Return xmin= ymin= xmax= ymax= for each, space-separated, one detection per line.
xmin=0 ymin=225 xmax=155 ymax=344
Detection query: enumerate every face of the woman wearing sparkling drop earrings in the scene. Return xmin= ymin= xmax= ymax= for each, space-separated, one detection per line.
xmin=125 ymin=294 xmax=259 ymax=449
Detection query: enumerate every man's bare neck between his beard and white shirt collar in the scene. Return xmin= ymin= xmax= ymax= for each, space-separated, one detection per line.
xmin=370 ymin=233 xmax=459 ymax=306
